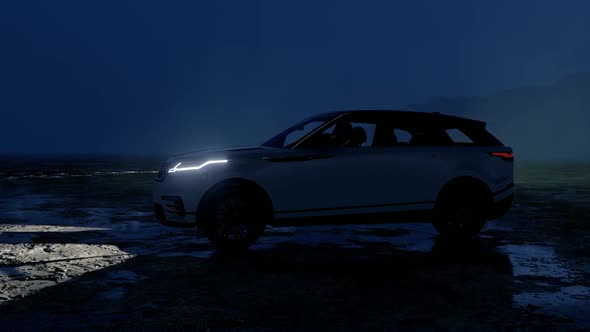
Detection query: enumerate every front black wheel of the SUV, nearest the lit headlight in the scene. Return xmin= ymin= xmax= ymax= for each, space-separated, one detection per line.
xmin=197 ymin=183 xmax=271 ymax=251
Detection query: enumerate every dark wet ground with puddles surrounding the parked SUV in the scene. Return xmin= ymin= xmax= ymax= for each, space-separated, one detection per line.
xmin=0 ymin=160 xmax=590 ymax=331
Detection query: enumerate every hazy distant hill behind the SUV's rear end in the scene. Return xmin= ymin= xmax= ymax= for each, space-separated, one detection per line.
xmin=408 ymin=73 xmax=590 ymax=160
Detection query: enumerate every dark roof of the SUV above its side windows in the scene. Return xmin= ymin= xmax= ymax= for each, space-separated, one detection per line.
xmin=324 ymin=110 xmax=486 ymax=127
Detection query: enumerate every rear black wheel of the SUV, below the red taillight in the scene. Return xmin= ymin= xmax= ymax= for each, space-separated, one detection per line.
xmin=432 ymin=185 xmax=490 ymax=239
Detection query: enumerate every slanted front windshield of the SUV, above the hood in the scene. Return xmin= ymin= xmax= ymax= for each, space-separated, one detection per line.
xmin=262 ymin=112 xmax=341 ymax=149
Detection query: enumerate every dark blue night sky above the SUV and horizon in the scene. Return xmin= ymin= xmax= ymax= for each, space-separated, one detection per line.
xmin=0 ymin=0 xmax=590 ymax=153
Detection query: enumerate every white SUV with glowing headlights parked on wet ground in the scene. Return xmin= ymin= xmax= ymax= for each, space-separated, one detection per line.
xmin=153 ymin=111 xmax=514 ymax=249
